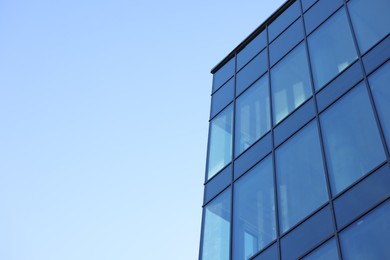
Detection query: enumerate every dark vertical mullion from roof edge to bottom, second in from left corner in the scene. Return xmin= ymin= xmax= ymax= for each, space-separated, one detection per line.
xmin=264 ymin=20 xmax=282 ymax=260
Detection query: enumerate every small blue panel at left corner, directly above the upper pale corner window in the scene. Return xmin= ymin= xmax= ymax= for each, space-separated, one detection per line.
xmin=210 ymin=78 xmax=234 ymax=117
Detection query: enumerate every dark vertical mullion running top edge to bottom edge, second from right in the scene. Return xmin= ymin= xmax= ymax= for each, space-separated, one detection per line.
xmin=300 ymin=2 xmax=342 ymax=259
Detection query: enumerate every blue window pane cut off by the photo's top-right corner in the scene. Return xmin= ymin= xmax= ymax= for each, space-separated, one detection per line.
xmin=348 ymin=0 xmax=390 ymax=53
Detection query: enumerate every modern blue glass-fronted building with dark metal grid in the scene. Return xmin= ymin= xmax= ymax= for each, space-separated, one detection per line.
xmin=199 ymin=0 xmax=390 ymax=260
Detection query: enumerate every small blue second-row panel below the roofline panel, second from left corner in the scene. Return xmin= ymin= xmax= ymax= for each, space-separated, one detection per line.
xmin=236 ymin=50 xmax=268 ymax=96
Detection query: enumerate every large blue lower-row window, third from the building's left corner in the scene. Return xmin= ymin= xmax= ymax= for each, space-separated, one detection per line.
xmin=276 ymin=122 xmax=328 ymax=232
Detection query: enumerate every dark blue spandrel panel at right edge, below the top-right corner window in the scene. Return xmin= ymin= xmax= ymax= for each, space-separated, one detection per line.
xmin=363 ymin=35 xmax=390 ymax=74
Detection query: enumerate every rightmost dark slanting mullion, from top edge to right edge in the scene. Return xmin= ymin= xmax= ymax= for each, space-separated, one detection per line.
xmin=344 ymin=2 xmax=390 ymax=162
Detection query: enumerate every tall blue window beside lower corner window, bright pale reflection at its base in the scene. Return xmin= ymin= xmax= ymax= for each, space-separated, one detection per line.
xmin=233 ymin=157 xmax=276 ymax=260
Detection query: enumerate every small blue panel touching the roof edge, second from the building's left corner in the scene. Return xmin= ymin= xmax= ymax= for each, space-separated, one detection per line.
xmin=237 ymin=30 xmax=267 ymax=70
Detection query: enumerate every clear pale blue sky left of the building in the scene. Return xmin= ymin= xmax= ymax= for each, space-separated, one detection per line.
xmin=0 ymin=0 xmax=284 ymax=260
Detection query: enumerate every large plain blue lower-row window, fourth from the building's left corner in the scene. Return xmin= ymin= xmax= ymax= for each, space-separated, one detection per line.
xmin=320 ymin=84 xmax=385 ymax=194
